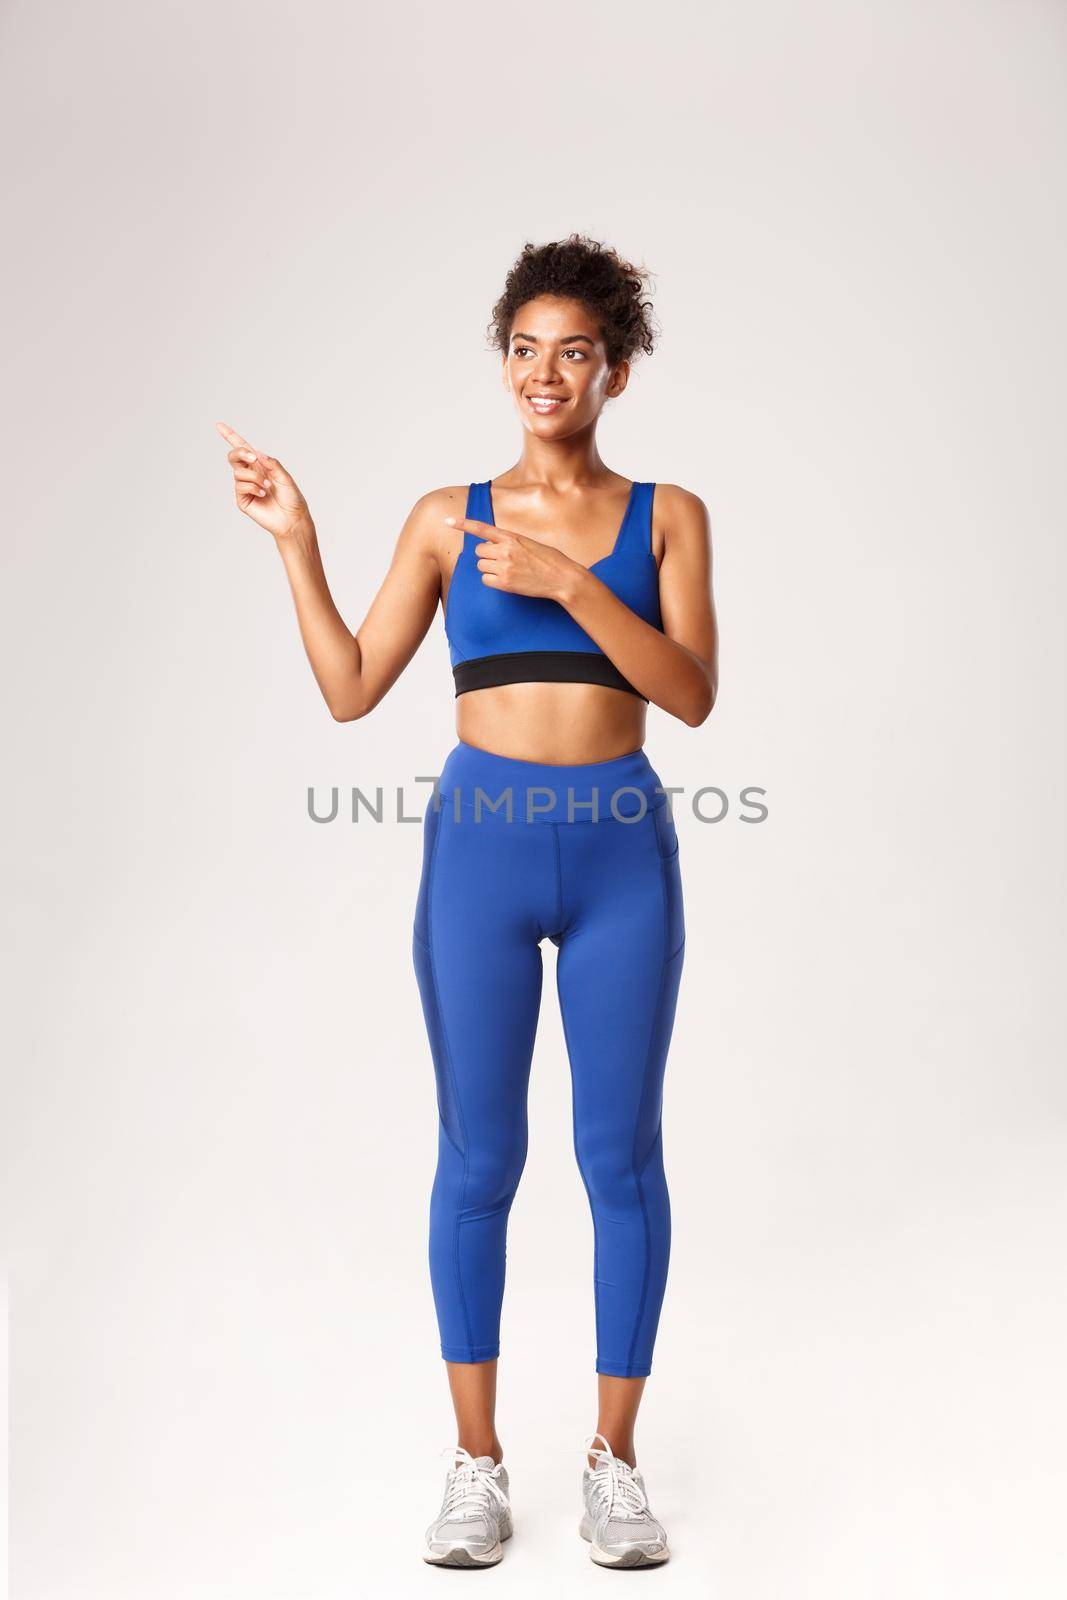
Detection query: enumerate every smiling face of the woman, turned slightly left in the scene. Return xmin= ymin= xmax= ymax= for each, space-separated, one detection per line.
xmin=502 ymin=294 xmax=630 ymax=438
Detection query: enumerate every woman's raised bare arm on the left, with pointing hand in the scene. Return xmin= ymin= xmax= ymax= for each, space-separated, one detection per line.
xmin=216 ymin=422 xmax=462 ymax=722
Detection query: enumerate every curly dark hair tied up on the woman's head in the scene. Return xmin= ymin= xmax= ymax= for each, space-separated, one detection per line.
xmin=488 ymin=234 xmax=657 ymax=366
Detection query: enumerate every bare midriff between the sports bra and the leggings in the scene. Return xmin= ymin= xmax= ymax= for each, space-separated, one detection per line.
xmin=456 ymin=683 xmax=648 ymax=766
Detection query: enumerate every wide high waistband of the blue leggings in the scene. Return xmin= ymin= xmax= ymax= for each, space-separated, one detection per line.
xmin=438 ymin=739 xmax=667 ymax=822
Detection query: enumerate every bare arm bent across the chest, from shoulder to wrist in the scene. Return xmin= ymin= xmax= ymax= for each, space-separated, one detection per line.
xmin=555 ymin=483 xmax=718 ymax=728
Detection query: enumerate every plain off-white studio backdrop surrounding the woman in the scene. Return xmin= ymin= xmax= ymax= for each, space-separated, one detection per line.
xmin=0 ymin=0 xmax=1067 ymax=1600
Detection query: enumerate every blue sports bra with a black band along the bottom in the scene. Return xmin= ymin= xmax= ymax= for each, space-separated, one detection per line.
xmin=445 ymin=480 xmax=664 ymax=701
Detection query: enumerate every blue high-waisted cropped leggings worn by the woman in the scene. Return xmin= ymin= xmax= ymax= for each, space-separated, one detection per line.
xmin=413 ymin=742 xmax=685 ymax=1378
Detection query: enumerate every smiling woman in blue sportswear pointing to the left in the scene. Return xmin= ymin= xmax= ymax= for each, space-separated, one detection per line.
xmin=218 ymin=235 xmax=717 ymax=1566
